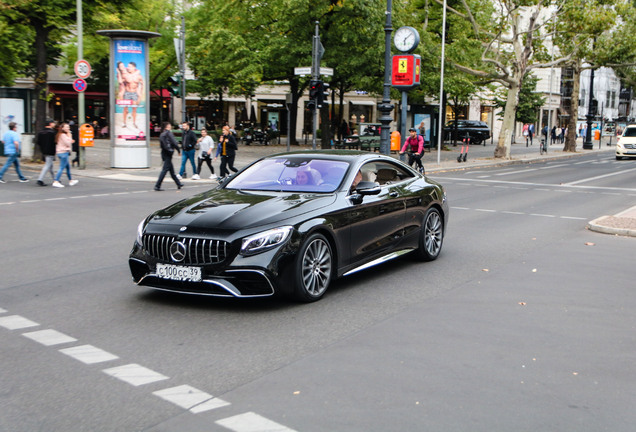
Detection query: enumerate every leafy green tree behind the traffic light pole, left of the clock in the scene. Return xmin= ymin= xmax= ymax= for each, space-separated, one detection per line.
xmin=188 ymin=0 xmax=384 ymax=143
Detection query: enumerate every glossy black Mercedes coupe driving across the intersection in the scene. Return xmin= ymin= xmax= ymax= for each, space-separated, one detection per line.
xmin=129 ymin=150 xmax=448 ymax=302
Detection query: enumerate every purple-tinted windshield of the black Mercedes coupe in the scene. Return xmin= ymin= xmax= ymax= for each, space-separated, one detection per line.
xmin=226 ymin=156 xmax=349 ymax=192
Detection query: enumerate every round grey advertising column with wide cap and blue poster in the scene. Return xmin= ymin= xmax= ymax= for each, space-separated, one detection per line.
xmin=97 ymin=30 xmax=160 ymax=168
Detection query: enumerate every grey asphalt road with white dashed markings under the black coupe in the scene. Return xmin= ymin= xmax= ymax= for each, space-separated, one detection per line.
xmin=0 ymin=153 xmax=636 ymax=432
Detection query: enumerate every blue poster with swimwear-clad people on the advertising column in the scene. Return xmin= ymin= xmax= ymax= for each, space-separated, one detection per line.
xmin=111 ymin=39 xmax=149 ymax=146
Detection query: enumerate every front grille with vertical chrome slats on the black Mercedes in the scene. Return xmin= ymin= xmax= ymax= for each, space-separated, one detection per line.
xmin=143 ymin=234 xmax=227 ymax=265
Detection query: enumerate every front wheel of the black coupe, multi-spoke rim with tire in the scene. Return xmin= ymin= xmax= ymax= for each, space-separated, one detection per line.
xmin=294 ymin=234 xmax=333 ymax=302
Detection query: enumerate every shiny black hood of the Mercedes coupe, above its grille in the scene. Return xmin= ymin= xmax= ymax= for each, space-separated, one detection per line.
xmin=148 ymin=189 xmax=336 ymax=230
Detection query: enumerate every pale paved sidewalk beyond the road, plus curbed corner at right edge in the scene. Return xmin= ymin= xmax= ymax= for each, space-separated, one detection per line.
xmin=21 ymin=138 xmax=636 ymax=237
